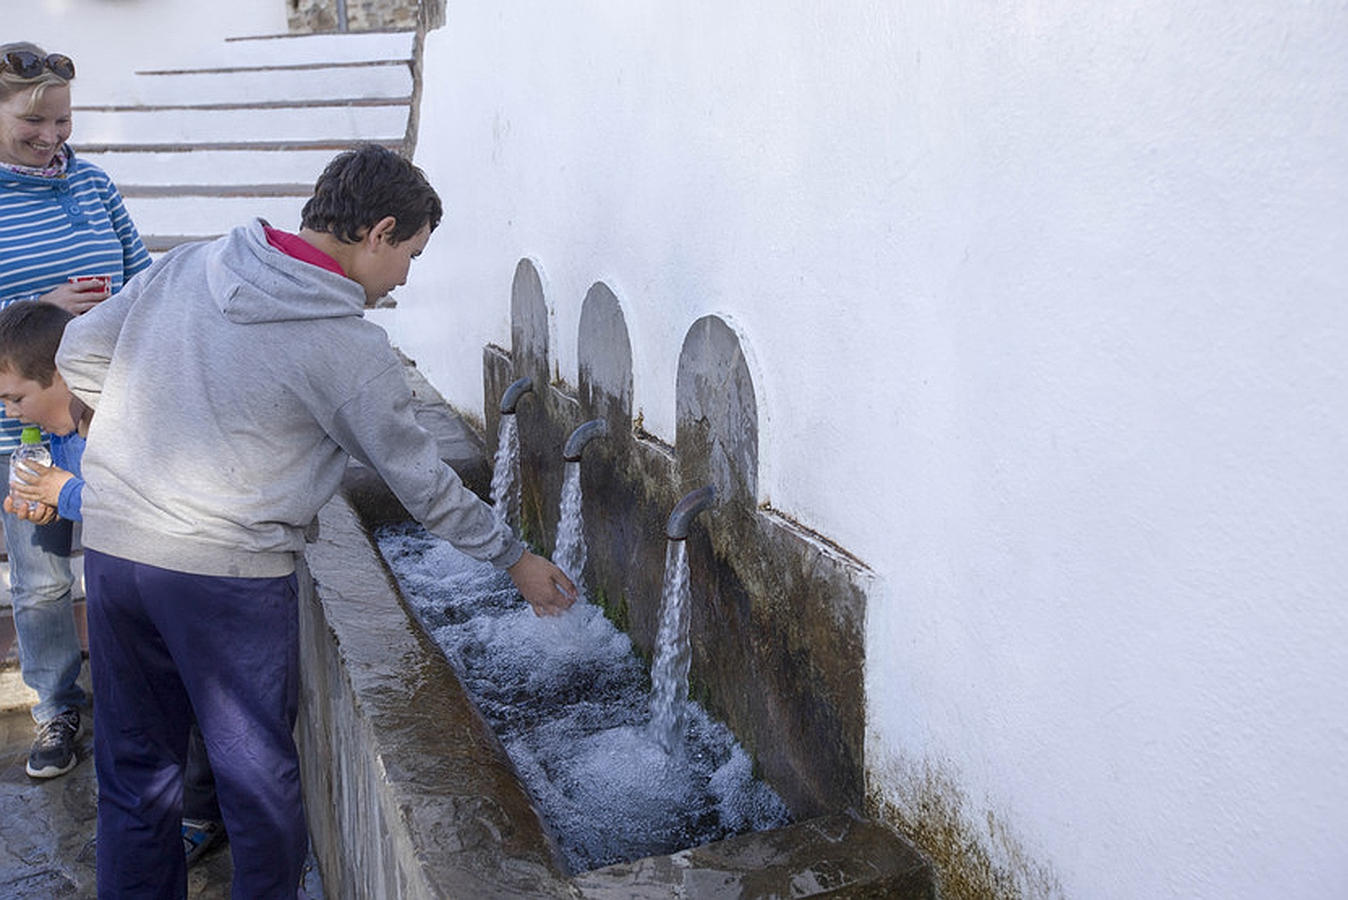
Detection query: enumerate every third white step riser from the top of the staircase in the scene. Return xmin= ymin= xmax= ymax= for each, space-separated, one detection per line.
xmin=74 ymin=105 xmax=408 ymax=146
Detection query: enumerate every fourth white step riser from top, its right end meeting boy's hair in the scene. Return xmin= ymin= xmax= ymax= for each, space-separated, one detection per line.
xmin=75 ymin=144 xmax=340 ymax=187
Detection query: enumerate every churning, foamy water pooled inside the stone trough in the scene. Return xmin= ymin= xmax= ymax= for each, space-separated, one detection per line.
xmin=377 ymin=524 xmax=790 ymax=872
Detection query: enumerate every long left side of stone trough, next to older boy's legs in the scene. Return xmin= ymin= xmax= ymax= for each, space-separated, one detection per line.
xmin=299 ymin=487 xmax=573 ymax=897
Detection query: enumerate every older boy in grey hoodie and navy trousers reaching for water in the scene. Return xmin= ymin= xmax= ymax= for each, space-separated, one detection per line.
xmin=57 ymin=147 xmax=576 ymax=897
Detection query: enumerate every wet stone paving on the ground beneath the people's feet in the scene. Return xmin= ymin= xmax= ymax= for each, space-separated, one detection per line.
xmin=0 ymin=710 xmax=322 ymax=900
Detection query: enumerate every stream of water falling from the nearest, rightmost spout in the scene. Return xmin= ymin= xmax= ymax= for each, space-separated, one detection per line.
xmin=651 ymin=540 xmax=693 ymax=753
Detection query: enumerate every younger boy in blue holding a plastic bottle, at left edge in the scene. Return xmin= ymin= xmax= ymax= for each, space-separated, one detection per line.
xmin=0 ymin=300 xmax=224 ymax=865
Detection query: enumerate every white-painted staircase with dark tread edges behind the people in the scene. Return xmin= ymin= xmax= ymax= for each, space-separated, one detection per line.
xmin=71 ymin=31 xmax=419 ymax=255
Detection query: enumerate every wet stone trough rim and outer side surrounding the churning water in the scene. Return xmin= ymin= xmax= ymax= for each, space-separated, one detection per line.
xmin=299 ymin=369 xmax=936 ymax=900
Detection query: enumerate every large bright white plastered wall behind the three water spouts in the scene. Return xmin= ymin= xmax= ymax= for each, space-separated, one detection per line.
xmin=388 ymin=0 xmax=1348 ymax=900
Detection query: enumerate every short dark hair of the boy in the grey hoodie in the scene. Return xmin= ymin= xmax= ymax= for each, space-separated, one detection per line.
xmin=301 ymin=144 xmax=442 ymax=244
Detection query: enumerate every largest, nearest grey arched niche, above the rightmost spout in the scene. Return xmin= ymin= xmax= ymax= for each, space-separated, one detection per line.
xmin=675 ymin=315 xmax=758 ymax=508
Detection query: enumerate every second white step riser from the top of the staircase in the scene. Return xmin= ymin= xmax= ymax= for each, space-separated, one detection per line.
xmin=111 ymin=61 xmax=412 ymax=107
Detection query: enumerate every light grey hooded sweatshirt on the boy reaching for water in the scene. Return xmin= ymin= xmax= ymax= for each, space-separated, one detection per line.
xmin=57 ymin=220 xmax=523 ymax=577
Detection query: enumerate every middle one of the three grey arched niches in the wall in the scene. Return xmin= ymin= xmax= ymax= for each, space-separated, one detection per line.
xmin=577 ymin=282 xmax=632 ymax=435
